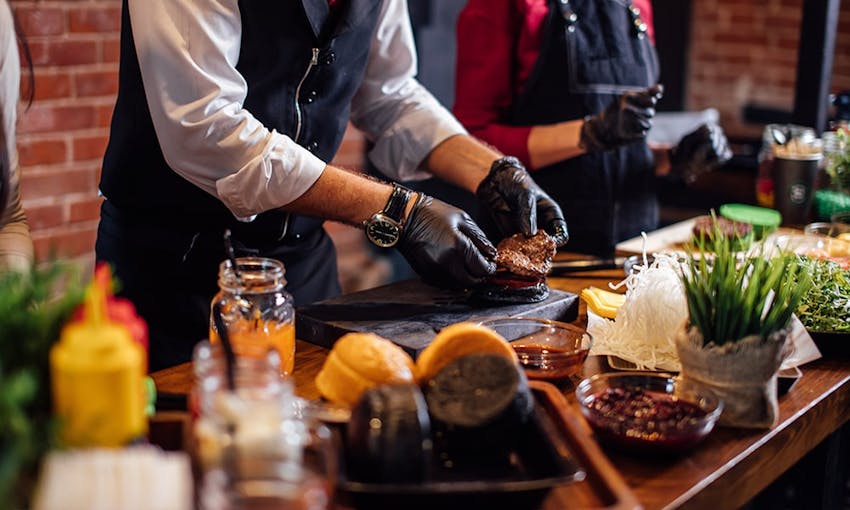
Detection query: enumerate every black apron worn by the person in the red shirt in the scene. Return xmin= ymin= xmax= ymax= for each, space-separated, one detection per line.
xmin=508 ymin=0 xmax=658 ymax=256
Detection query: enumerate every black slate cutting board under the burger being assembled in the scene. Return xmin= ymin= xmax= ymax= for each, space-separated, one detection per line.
xmin=295 ymin=280 xmax=578 ymax=356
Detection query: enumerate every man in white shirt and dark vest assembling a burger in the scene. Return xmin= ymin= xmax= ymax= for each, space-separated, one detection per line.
xmin=97 ymin=0 xmax=567 ymax=370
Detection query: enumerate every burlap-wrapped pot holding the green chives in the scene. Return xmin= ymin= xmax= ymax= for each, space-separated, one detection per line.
xmin=676 ymin=323 xmax=788 ymax=429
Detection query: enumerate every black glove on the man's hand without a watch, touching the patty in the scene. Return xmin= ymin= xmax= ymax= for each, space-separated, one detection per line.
xmin=476 ymin=157 xmax=570 ymax=246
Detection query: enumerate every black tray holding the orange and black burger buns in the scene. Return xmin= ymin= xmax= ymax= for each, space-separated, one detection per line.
xmin=338 ymin=386 xmax=585 ymax=510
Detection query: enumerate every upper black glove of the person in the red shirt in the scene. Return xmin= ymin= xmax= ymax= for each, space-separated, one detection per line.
xmin=579 ymin=85 xmax=664 ymax=152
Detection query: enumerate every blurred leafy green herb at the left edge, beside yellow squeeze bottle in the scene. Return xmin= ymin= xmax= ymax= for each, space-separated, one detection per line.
xmin=0 ymin=262 xmax=83 ymax=509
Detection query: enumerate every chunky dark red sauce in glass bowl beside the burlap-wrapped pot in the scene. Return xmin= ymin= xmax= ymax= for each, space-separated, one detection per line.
xmin=588 ymin=388 xmax=710 ymax=450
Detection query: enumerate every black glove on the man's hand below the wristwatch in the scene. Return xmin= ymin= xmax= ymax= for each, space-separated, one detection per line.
xmin=398 ymin=195 xmax=496 ymax=287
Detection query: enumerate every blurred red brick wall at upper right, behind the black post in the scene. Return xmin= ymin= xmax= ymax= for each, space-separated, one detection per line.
xmin=687 ymin=0 xmax=850 ymax=137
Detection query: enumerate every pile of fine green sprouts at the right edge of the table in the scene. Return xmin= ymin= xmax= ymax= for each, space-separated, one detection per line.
xmin=797 ymin=256 xmax=850 ymax=333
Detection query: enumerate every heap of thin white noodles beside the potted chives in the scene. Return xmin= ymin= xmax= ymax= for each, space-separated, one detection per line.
xmin=588 ymin=251 xmax=688 ymax=371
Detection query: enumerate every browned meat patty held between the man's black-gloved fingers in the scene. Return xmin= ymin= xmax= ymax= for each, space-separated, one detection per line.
xmin=496 ymin=230 xmax=557 ymax=278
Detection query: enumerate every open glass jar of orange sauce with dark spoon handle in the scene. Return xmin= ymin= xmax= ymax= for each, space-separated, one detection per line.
xmin=210 ymin=257 xmax=295 ymax=374
